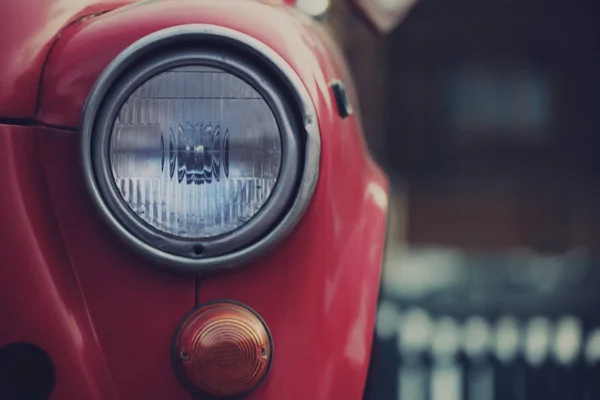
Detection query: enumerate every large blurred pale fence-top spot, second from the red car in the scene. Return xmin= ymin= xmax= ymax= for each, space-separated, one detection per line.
xmin=398 ymin=308 xmax=433 ymax=352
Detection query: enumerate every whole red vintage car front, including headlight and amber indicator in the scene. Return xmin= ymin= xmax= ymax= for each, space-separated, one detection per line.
xmin=0 ymin=0 xmax=388 ymax=400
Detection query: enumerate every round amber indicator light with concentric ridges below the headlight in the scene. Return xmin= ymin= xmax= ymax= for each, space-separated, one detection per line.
xmin=173 ymin=302 xmax=273 ymax=397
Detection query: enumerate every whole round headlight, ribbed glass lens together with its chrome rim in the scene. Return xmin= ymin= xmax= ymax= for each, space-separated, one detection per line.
xmin=82 ymin=25 xmax=320 ymax=272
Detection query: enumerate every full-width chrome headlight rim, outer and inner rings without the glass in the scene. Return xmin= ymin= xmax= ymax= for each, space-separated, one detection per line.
xmin=82 ymin=25 xmax=320 ymax=273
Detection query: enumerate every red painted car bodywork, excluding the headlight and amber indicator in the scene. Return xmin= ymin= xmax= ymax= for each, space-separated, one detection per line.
xmin=0 ymin=0 xmax=388 ymax=400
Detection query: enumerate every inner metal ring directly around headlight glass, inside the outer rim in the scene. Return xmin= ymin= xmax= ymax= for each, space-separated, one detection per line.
xmin=91 ymin=49 xmax=300 ymax=259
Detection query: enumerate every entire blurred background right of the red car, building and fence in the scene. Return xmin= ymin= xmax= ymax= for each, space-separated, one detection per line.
xmin=307 ymin=0 xmax=600 ymax=400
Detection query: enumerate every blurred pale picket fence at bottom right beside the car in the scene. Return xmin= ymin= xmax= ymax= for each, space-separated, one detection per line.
xmin=371 ymin=309 xmax=600 ymax=400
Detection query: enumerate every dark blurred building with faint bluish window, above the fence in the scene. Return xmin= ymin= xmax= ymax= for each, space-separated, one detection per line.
xmin=385 ymin=0 xmax=600 ymax=252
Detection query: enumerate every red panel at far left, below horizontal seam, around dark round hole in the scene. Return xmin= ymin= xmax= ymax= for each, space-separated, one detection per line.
xmin=0 ymin=125 xmax=116 ymax=400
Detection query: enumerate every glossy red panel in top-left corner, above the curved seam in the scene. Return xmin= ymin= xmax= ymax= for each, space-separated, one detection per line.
xmin=0 ymin=0 xmax=133 ymax=118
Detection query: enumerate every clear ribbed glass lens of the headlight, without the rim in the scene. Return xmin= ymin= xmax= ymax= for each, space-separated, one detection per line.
xmin=110 ymin=66 xmax=282 ymax=238
